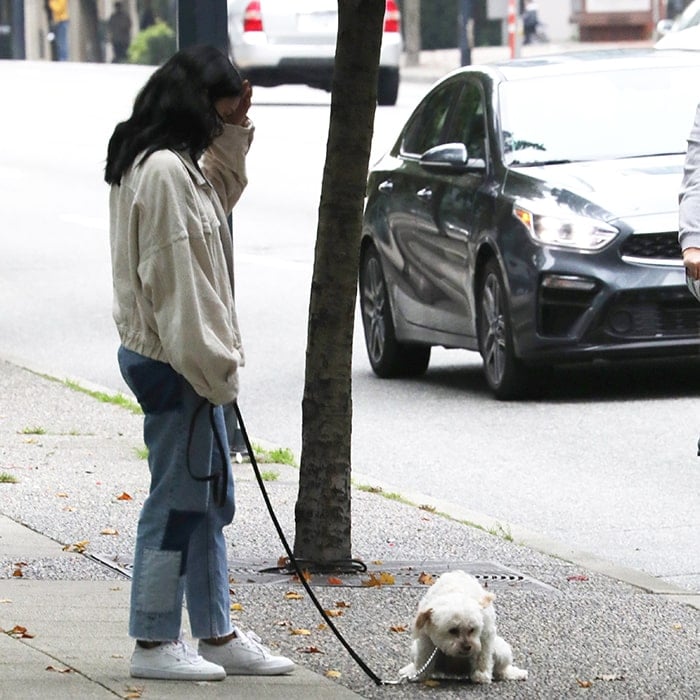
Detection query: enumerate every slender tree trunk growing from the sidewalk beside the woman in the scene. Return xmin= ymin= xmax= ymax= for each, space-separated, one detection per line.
xmin=294 ymin=0 xmax=385 ymax=569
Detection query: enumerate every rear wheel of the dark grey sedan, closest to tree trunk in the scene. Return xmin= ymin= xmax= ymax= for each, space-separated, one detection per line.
xmin=360 ymin=247 xmax=430 ymax=378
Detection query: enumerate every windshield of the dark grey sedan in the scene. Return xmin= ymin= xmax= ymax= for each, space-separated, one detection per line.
xmin=500 ymin=66 xmax=700 ymax=170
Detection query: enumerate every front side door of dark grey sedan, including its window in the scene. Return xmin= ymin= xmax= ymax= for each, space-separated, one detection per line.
xmin=394 ymin=76 xmax=487 ymax=342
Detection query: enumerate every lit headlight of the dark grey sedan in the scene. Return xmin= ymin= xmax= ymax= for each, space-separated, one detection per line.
xmin=513 ymin=205 xmax=619 ymax=250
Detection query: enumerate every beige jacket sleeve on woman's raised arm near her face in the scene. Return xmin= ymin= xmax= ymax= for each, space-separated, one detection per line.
xmin=200 ymin=120 xmax=255 ymax=214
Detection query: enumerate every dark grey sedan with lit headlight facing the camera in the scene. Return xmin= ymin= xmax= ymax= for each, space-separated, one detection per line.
xmin=359 ymin=48 xmax=700 ymax=398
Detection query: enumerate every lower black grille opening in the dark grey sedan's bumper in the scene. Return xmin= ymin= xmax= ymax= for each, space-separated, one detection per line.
xmin=603 ymin=287 xmax=700 ymax=340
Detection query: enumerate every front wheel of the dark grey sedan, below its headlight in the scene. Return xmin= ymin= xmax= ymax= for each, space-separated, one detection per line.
xmin=478 ymin=260 xmax=529 ymax=399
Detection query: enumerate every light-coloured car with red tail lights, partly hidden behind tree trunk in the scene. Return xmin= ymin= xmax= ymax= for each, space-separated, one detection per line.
xmin=228 ymin=0 xmax=403 ymax=105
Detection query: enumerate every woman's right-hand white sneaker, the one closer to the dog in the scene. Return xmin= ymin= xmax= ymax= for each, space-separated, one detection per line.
xmin=199 ymin=627 xmax=294 ymax=676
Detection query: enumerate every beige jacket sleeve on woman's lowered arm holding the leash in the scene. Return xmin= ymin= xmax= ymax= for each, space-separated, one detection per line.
xmin=138 ymin=154 xmax=243 ymax=405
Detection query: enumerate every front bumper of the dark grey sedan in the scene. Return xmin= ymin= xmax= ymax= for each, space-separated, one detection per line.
xmin=508 ymin=246 xmax=700 ymax=363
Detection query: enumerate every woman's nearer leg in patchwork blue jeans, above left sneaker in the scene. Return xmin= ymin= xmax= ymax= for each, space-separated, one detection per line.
xmin=120 ymin=348 xmax=219 ymax=641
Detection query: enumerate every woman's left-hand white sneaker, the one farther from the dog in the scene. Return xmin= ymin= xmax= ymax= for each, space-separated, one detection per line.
xmin=130 ymin=640 xmax=226 ymax=681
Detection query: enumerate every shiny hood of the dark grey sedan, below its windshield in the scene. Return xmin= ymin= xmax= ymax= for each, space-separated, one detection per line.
xmin=506 ymin=154 xmax=684 ymax=229
